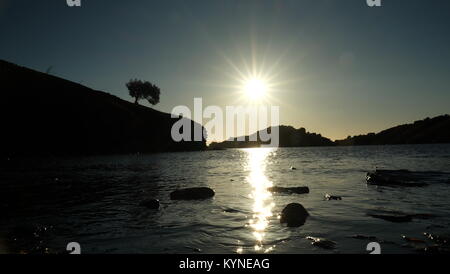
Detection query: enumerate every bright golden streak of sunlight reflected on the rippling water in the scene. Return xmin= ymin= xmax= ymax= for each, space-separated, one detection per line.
xmin=245 ymin=148 xmax=275 ymax=252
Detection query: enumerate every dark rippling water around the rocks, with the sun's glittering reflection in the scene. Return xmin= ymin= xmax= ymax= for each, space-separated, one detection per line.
xmin=0 ymin=145 xmax=450 ymax=253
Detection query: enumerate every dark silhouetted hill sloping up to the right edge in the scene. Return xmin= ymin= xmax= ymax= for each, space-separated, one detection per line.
xmin=336 ymin=115 xmax=450 ymax=145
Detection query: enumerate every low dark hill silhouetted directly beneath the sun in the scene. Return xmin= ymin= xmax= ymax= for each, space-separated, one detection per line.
xmin=209 ymin=126 xmax=334 ymax=149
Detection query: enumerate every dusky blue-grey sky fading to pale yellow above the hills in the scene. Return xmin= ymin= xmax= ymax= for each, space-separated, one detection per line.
xmin=0 ymin=0 xmax=450 ymax=140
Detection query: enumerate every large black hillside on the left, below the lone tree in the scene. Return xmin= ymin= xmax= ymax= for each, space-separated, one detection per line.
xmin=0 ymin=60 xmax=206 ymax=156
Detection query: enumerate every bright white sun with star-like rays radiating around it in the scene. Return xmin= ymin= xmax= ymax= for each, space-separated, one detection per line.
xmin=208 ymin=38 xmax=302 ymax=106
